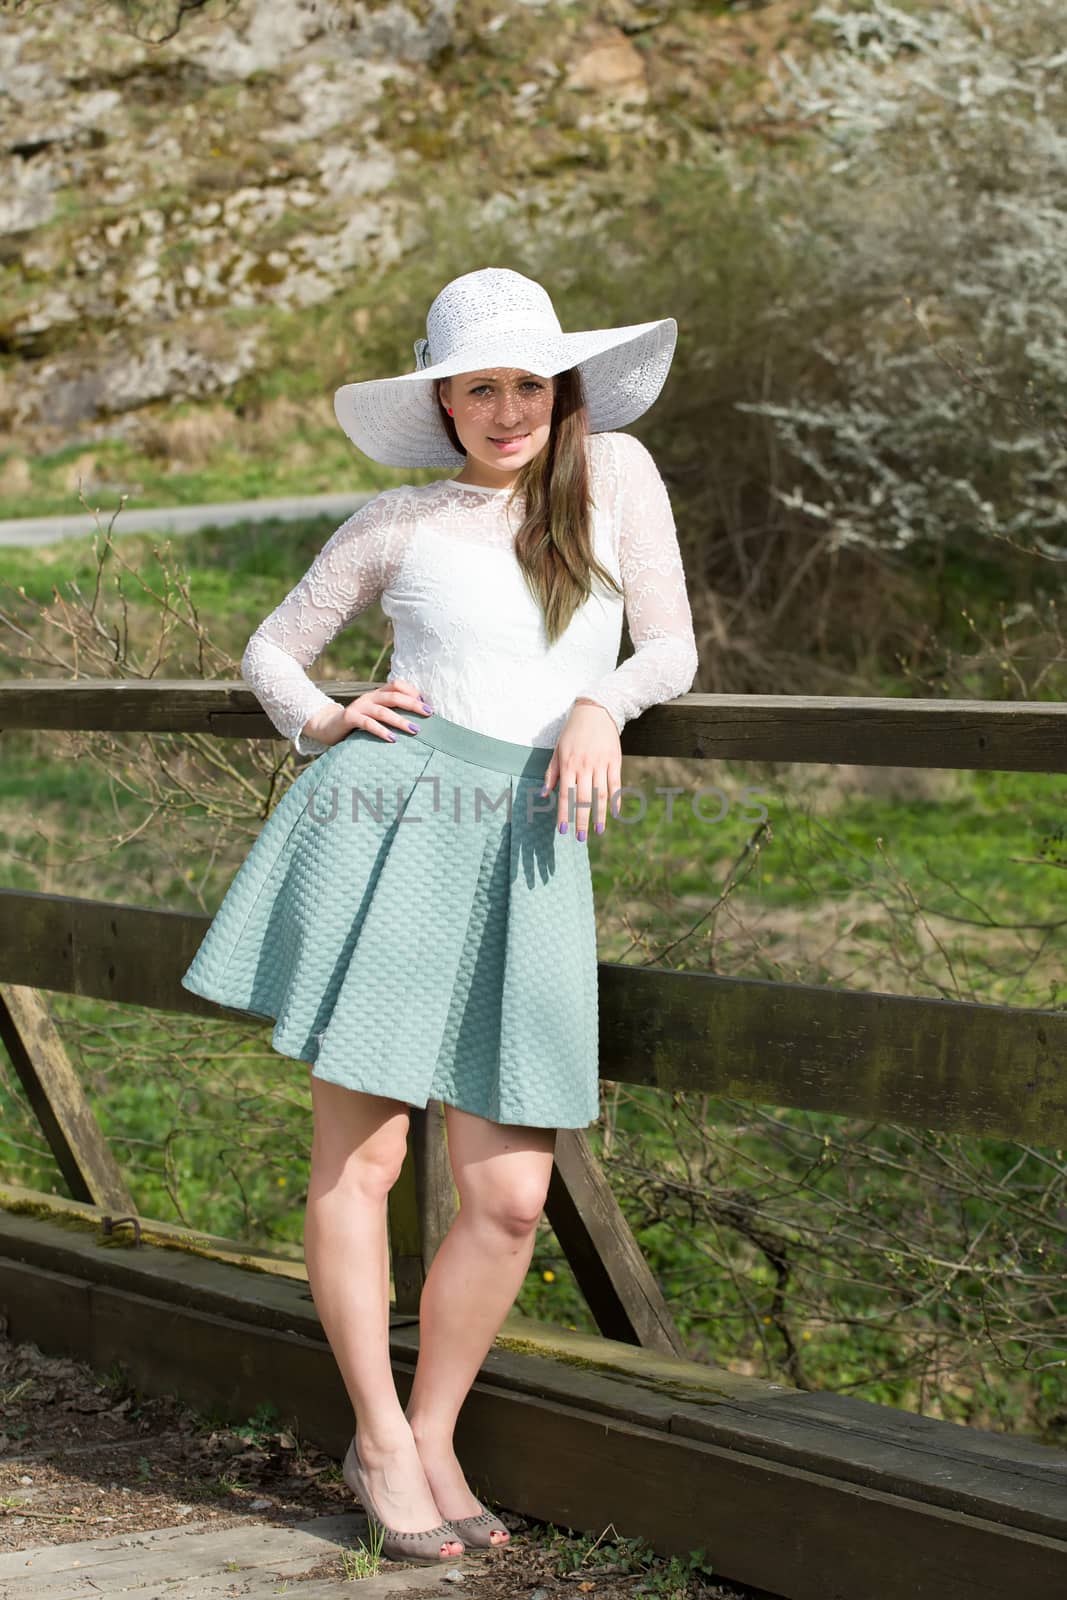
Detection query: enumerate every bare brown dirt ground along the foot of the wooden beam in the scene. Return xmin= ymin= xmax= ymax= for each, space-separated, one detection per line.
xmin=0 ymin=1328 xmax=765 ymax=1600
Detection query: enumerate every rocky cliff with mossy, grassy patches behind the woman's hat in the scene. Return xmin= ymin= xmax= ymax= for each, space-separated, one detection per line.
xmin=0 ymin=0 xmax=808 ymax=467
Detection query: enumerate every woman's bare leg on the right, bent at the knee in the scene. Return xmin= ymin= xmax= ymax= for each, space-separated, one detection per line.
xmin=406 ymin=1104 xmax=555 ymax=1544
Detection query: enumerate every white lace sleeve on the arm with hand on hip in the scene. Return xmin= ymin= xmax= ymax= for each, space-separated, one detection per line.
xmin=242 ymin=490 xmax=405 ymax=755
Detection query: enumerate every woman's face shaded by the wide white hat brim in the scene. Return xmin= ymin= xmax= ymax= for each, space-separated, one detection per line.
xmin=440 ymin=366 xmax=555 ymax=488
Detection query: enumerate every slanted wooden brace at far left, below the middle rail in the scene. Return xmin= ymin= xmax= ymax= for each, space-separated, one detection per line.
xmin=0 ymin=982 xmax=138 ymax=1216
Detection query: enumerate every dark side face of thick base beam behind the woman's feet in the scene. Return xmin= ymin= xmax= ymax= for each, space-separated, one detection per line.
xmin=0 ymin=1259 xmax=1067 ymax=1600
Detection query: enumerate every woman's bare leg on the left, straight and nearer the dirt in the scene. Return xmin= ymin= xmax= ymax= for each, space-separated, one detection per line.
xmin=304 ymin=1074 xmax=462 ymax=1555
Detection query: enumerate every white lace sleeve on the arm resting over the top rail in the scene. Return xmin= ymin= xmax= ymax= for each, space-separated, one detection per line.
xmin=577 ymin=434 xmax=699 ymax=733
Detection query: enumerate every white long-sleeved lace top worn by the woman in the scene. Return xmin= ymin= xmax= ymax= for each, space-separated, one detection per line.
xmin=242 ymin=434 xmax=697 ymax=755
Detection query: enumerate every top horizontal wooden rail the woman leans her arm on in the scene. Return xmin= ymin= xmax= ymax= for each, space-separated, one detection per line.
xmin=0 ymin=678 xmax=1067 ymax=773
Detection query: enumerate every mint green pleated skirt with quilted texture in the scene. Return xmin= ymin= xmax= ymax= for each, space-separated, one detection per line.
xmin=181 ymin=715 xmax=600 ymax=1128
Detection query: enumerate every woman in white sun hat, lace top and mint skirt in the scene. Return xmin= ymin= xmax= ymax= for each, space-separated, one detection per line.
xmin=182 ymin=267 xmax=697 ymax=1562
